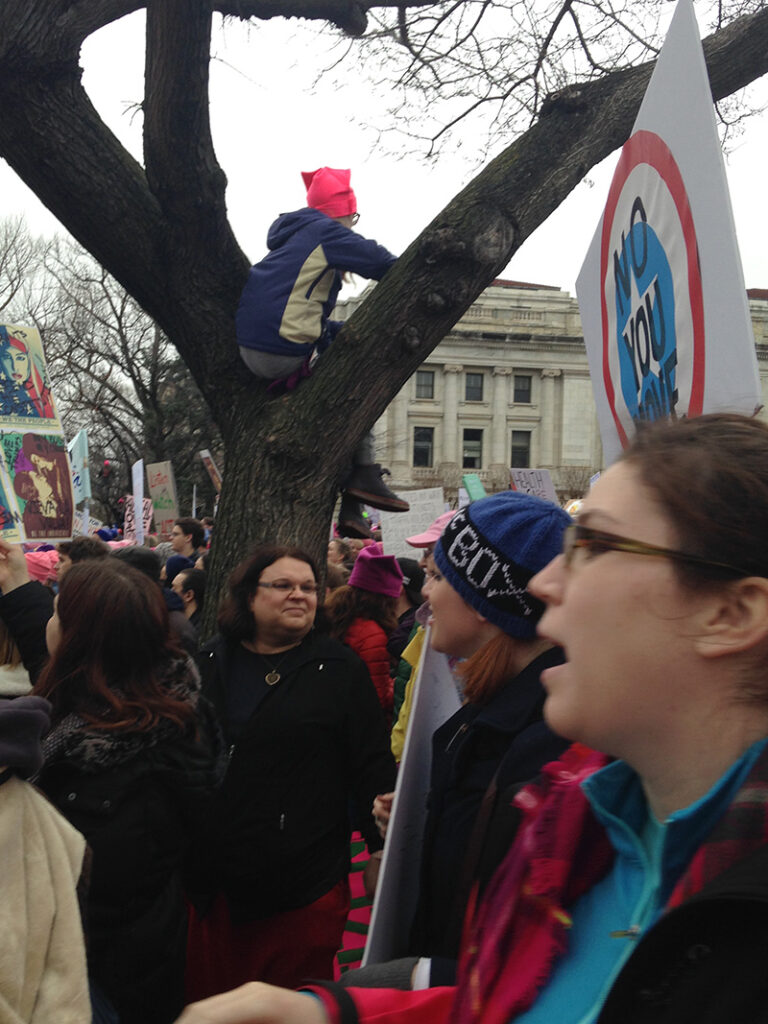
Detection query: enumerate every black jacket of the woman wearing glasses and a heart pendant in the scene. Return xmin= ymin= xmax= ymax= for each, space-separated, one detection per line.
xmin=198 ymin=633 xmax=394 ymax=921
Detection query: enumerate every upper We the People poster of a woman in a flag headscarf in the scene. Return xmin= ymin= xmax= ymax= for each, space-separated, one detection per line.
xmin=0 ymin=324 xmax=61 ymax=432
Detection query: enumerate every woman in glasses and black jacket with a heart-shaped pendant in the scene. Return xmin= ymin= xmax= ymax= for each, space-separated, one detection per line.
xmin=187 ymin=547 xmax=394 ymax=997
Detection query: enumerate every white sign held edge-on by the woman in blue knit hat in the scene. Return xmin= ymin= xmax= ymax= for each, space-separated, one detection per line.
xmin=362 ymin=630 xmax=461 ymax=967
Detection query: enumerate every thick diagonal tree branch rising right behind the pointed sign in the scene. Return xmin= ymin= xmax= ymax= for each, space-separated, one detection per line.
xmin=264 ymin=2 xmax=768 ymax=463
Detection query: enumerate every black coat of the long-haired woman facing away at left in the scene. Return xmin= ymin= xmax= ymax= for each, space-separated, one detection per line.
xmin=37 ymin=663 xmax=223 ymax=1024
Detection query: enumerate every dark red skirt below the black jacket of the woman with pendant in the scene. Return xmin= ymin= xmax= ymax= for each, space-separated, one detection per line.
xmin=186 ymin=879 xmax=349 ymax=1002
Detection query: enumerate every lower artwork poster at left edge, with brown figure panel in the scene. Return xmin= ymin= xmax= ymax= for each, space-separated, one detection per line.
xmin=0 ymin=431 xmax=75 ymax=542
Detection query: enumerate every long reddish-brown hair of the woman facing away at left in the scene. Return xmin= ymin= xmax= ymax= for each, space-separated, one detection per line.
xmin=34 ymin=558 xmax=195 ymax=732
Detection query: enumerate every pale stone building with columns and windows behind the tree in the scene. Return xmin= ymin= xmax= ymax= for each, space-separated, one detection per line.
xmin=335 ymin=280 xmax=768 ymax=501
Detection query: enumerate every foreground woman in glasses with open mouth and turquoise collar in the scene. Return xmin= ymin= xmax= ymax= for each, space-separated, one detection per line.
xmin=181 ymin=415 xmax=768 ymax=1024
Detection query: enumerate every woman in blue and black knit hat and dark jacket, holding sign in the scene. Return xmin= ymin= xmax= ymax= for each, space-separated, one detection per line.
xmin=352 ymin=490 xmax=570 ymax=988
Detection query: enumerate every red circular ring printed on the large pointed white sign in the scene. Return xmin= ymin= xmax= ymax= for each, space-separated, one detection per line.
xmin=600 ymin=131 xmax=705 ymax=447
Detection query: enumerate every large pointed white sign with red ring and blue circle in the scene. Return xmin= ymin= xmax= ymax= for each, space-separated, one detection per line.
xmin=577 ymin=0 xmax=761 ymax=463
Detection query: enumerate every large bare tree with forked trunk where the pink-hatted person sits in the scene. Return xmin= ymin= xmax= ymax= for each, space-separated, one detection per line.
xmin=0 ymin=0 xmax=768 ymax=630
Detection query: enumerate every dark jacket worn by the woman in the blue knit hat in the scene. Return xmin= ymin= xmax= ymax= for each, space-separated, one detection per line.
xmin=412 ymin=649 xmax=568 ymax=958
